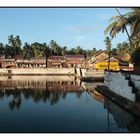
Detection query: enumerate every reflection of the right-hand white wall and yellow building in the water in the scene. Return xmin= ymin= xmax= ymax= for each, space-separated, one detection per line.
xmin=85 ymin=83 xmax=140 ymax=132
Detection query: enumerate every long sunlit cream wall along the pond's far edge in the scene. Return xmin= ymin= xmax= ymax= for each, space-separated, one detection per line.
xmin=0 ymin=68 xmax=75 ymax=75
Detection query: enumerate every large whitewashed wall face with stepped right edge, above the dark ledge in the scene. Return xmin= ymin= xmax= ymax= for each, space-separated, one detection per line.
xmin=104 ymin=72 xmax=136 ymax=102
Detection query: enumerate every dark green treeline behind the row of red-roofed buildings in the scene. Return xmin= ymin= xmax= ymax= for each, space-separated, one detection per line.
xmin=0 ymin=35 xmax=104 ymax=60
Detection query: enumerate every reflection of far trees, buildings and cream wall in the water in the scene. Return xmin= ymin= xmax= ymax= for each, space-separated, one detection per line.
xmin=0 ymin=76 xmax=84 ymax=110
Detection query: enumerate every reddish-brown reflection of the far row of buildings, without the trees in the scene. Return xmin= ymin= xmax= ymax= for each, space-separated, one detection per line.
xmin=0 ymin=76 xmax=83 ymax=93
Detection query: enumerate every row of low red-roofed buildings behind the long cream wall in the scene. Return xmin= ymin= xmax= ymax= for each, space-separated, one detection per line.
xmin=0 ymin=54 xmax=85 ymax=68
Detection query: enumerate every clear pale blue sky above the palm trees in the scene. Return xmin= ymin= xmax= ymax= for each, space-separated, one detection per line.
xmin=0 ymin=7 xmax=128 ymax=49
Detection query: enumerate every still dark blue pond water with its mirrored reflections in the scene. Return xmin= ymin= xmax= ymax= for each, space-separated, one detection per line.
xmin=0 ymin=76 xmax=140 ymax=132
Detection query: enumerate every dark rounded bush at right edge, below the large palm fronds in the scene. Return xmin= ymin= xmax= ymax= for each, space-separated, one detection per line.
xmin=131 ymin=47 xmax=140 ymax=66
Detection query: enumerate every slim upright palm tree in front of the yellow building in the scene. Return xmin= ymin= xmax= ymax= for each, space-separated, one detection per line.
xmin=104 ymin=37 xmax=111 ymax=70
